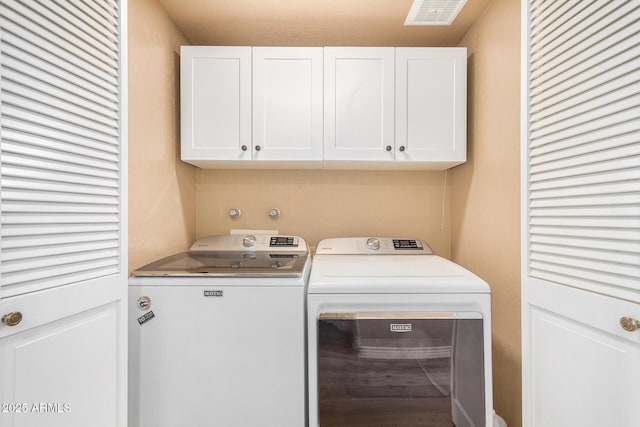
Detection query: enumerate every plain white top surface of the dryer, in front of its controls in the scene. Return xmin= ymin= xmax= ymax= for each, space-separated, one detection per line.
xmin=308 ymin=255 xmax=489 ymax=294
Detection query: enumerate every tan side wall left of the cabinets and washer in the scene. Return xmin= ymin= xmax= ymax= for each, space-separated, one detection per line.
xmin=128 ymin=0 xmax=196 ymax=271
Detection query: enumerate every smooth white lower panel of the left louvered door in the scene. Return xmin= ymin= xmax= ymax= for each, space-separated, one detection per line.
xmin=0 ymin=284 xmax=126 ymax=427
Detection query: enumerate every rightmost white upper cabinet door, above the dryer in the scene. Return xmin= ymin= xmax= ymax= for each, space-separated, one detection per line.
xmin=396 ymin=48 xmax=467 ymax=169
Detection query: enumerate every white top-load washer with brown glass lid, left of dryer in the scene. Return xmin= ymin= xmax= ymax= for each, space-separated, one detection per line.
xmin=129 ymin=235 xmax=310 ymax=427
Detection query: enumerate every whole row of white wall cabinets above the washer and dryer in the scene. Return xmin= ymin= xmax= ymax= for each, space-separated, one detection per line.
xmin=181 ymin=46 xmax=467 ymax=169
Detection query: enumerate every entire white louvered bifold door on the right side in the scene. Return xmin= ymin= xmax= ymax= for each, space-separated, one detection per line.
xmin=521 ymin=0 xmax=640 ymax=427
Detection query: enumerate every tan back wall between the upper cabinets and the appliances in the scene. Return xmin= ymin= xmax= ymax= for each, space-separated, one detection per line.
xmin=196 ymin=170 xmax=450 ymax=257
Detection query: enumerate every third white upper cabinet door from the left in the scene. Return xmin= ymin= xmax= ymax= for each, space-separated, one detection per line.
xmin=324 ymin=47 xmax=394 ymax=161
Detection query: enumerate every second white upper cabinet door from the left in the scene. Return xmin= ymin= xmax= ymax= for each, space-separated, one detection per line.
xmin=253 ymin=47 xmax=322 ymax=161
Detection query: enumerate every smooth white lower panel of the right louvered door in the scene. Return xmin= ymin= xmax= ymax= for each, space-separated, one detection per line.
xmin=523 ymin=281 xmax=640 ymax=427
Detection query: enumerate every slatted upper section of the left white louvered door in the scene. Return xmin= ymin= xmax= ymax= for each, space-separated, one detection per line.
xmin=0 ymin=0 xmax=123 ymax=297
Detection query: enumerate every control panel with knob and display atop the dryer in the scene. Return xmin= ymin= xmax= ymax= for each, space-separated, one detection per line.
xmin=316 ymin=237 xmax=433 ymax=255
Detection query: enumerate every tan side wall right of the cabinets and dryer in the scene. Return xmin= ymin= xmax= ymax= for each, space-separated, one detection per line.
xmin=451 ymin=0 xmax=522 ymax=427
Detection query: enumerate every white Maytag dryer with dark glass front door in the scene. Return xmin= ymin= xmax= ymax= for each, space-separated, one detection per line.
xmin=307 ymin=238 xmax=493 ymax=427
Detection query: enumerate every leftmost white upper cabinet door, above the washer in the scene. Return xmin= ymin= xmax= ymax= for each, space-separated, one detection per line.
xmin=180 ymin=46 xmax=251 ymax=165
